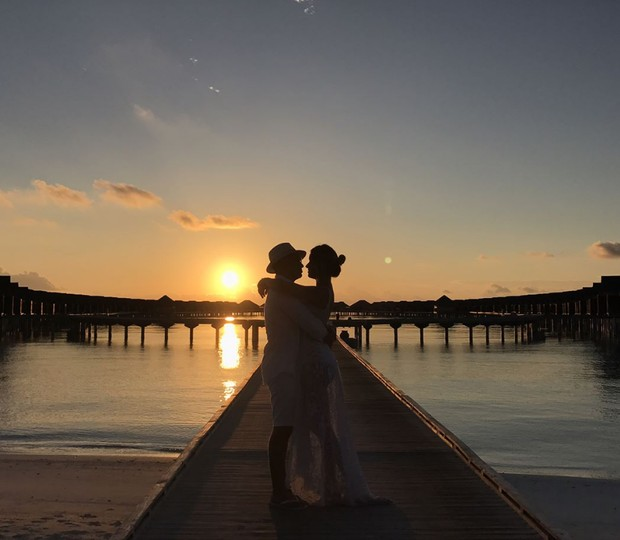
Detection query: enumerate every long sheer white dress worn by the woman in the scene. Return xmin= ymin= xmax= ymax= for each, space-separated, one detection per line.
xmin=287 ymin=293 xmax=378 ymax=506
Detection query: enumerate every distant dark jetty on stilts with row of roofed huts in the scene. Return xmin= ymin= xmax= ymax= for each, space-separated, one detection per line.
xmin=0 ymin=276 xmax=620 ymax=348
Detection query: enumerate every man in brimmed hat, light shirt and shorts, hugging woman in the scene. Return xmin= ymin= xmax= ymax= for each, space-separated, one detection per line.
xmin=261 ymin=242 xmax=328 ymax=508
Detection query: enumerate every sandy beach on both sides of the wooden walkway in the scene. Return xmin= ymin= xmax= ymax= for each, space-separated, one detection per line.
xmin=0 ymin=453 xmax=620 ymax=540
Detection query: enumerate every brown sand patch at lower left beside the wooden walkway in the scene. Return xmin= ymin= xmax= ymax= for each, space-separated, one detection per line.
xmin=0 ymin=454 xmax=174 ymax=540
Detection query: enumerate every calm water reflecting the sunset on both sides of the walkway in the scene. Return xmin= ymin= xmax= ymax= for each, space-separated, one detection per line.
xmin=0 ymin=325 xmax=620 ymax=478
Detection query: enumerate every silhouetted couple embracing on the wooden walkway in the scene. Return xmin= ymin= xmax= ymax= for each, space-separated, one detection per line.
xmin=258 ymin=243 xmax=389 ymax=508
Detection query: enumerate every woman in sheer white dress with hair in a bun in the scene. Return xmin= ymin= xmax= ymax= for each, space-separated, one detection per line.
xmin=258 ymin=244 xmax=389 ymax=506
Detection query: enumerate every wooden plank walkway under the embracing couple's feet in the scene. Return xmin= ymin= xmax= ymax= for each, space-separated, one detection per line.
xmin=117 ymin=343 xmax=558 ymax=540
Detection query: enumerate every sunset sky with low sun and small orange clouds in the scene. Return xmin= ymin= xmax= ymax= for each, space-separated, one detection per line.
xmin=0 ymin=0 xmax=620 ymax=303
